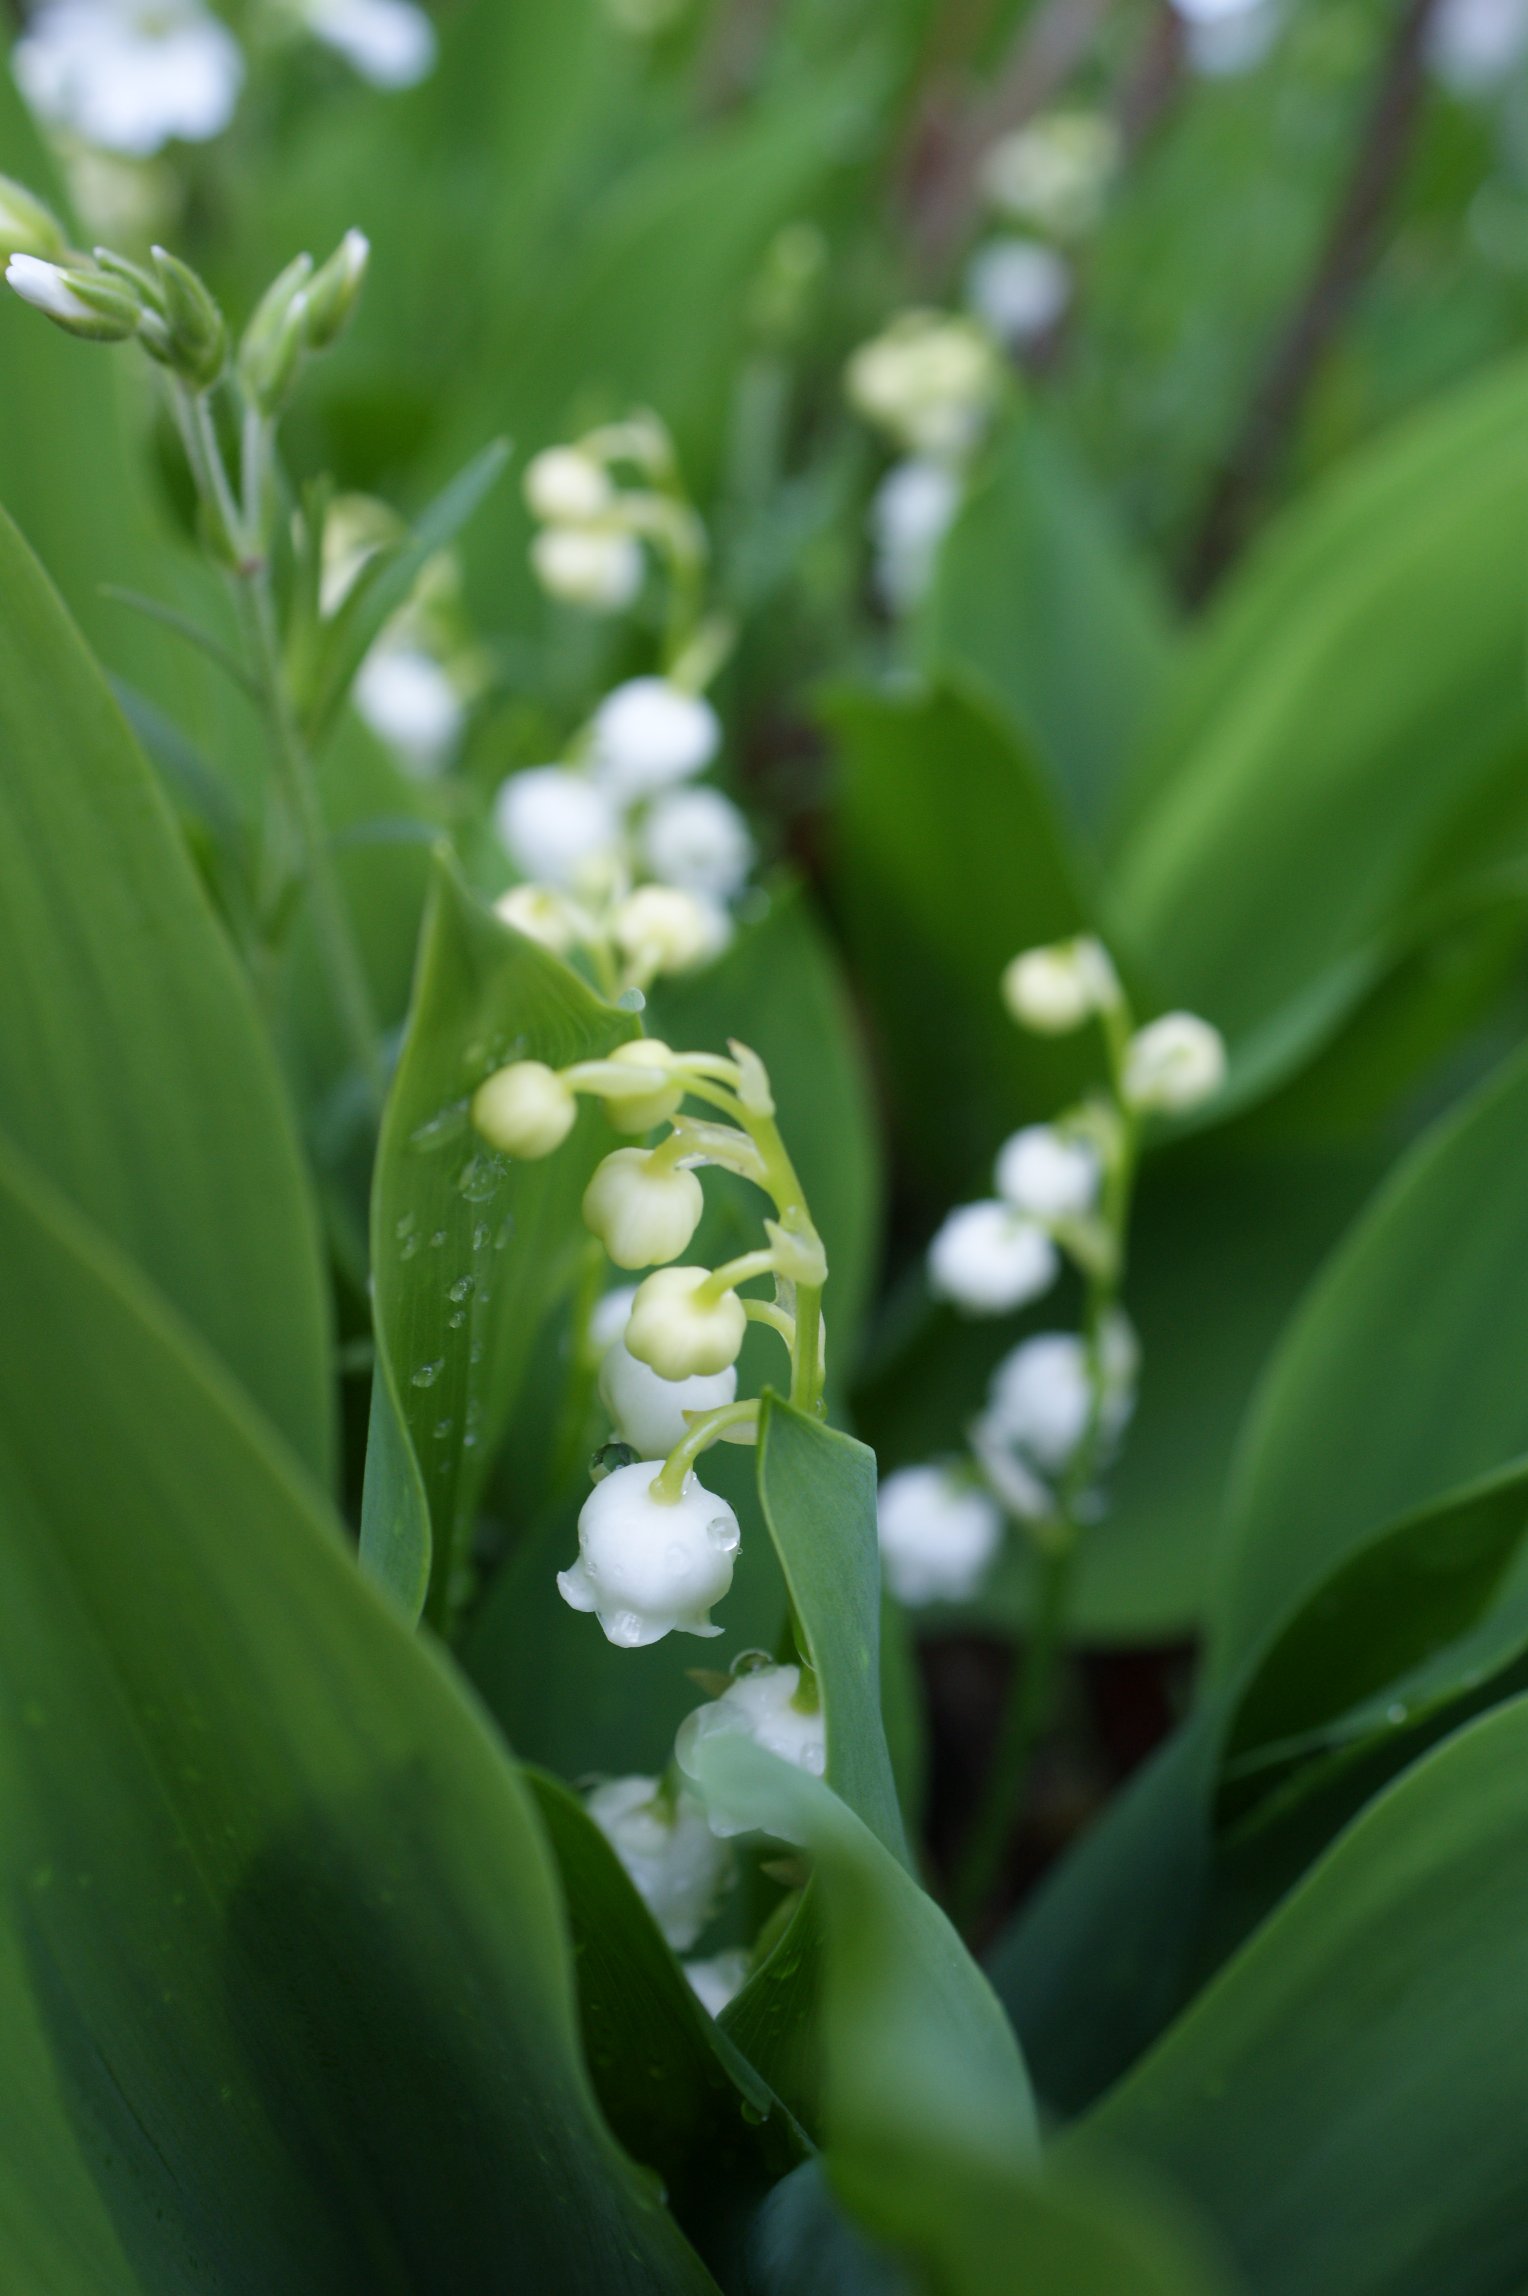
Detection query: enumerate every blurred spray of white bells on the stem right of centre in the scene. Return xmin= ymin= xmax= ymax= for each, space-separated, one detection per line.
xmin=879 ymin=937 xmax=1225 ymax=1605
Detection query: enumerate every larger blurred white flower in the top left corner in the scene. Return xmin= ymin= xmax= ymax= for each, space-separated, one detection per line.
xmin=11 ymin=0 xmax=243 ymax=158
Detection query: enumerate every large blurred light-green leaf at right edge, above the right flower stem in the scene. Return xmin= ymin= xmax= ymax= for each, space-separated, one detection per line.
xmin=1113 ymin=363 xmax=1528 ymax=1040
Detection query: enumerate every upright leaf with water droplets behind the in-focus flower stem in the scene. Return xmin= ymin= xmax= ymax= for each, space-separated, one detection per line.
xmin=360 ymin=859 xmax=633 ymax=1626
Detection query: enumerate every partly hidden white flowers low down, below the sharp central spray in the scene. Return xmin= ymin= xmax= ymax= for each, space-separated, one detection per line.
xmin=585 ymin=1655 xmax=826 ymax=2016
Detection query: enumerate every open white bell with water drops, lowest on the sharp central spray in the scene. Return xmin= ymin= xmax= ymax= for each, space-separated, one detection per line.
xmin=558 ymin=1460 xmax=741 ymax=1651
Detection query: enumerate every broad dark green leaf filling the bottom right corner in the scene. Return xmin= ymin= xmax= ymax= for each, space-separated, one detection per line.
xmin=1065 ymin=1699 xmax=1528 ymax=2296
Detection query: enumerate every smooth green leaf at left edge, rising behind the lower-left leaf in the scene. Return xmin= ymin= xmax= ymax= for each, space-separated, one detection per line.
xmin=0 ymin=502 xmax=333 ymax=1476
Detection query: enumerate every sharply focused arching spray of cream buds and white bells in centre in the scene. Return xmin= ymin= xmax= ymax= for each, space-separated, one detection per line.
xmin=473 ymin=1038 xmax=826 ymax=1649
